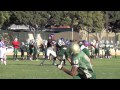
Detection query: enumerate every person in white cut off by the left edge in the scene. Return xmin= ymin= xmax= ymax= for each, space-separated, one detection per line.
xmin=0 ymin=37 xmax=7 ymax=65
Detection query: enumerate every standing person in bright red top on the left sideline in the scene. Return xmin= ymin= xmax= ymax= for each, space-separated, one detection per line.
xmin=12 ymin=38 xmax=20 ymax=60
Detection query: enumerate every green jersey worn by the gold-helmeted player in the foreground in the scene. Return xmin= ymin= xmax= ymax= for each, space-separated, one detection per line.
xmin=72 ymin=51 xmax=94 ymax=78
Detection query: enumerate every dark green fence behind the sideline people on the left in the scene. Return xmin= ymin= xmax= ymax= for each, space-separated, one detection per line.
xmin=0 ymin=30 xmax=51 ymax=45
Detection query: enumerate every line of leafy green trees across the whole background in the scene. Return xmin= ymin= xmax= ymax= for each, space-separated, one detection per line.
xmin=0 ymin=11 xmax=120 ymax=32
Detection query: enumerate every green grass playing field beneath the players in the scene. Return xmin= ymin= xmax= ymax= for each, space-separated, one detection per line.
xmin=0 ymin=57 xmax=120 ymax=79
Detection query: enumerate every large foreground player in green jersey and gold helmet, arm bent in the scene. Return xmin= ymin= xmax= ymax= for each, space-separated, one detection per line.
xmin=57 ymin=43 xmax=96 ymax=79
